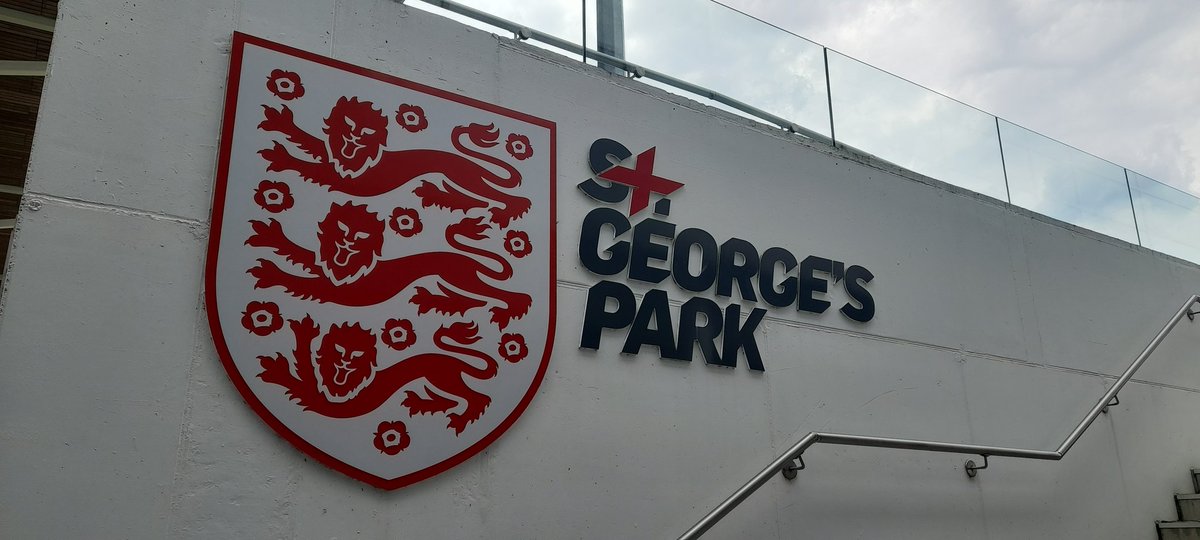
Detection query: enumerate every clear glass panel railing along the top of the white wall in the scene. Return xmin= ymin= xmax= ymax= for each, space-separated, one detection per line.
xmin=409 ymin=0 xmax=1200 ymax=263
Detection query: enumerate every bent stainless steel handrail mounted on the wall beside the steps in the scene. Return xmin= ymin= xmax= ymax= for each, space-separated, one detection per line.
xmin=679 ymin=294 xmax=1200 ymax=540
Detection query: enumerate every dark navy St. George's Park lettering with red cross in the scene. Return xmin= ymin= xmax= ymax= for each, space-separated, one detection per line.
xmin=578 ymin=139 xmax=875 ymax=371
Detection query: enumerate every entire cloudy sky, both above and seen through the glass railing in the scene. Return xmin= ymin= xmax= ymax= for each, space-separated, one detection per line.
xmin=410 ymin=0 xmax=1200 ymax=262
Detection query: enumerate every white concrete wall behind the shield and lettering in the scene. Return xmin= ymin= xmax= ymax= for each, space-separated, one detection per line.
xmin=0 ymin=0 xmax=1200 ymax=539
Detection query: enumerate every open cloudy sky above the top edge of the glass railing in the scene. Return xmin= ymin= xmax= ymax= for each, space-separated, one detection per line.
xmin=722 ymin=0 xmax=1200 ymax=194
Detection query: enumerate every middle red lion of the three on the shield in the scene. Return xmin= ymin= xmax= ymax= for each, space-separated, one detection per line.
xmin=246 ymin=203 xmax=533 ymax=330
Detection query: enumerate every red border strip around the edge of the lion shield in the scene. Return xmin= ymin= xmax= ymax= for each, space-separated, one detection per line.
xmin=204 ymin=32 xmax=558 ymax=490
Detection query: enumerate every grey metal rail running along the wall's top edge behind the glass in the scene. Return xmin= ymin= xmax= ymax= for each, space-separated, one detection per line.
xmin=398 ymin=0 xmax=833 ymax=145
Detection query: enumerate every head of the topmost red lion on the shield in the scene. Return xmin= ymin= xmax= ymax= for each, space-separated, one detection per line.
xmin=323 ymin=97 xmax=388 ymax=178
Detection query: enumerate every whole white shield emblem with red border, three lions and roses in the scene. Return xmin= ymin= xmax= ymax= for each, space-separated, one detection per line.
xmin=205 ymin=34 xmax=556 ymax=488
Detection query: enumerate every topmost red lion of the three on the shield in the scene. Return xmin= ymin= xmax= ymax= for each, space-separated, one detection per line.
xmin=258 ymin=97 xmax=529 ymax=228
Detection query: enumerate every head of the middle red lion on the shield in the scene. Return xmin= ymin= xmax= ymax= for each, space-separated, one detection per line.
xmin=317 ymin=203 xmax=384 ymax=286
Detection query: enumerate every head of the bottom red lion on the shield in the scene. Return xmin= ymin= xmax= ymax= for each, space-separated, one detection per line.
xmin=313 ymin=323 xmax=376 ymax=403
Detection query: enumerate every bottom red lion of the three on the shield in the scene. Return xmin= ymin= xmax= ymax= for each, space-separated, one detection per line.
xmin=258 ymin=316 xmax=499 ymax=434
